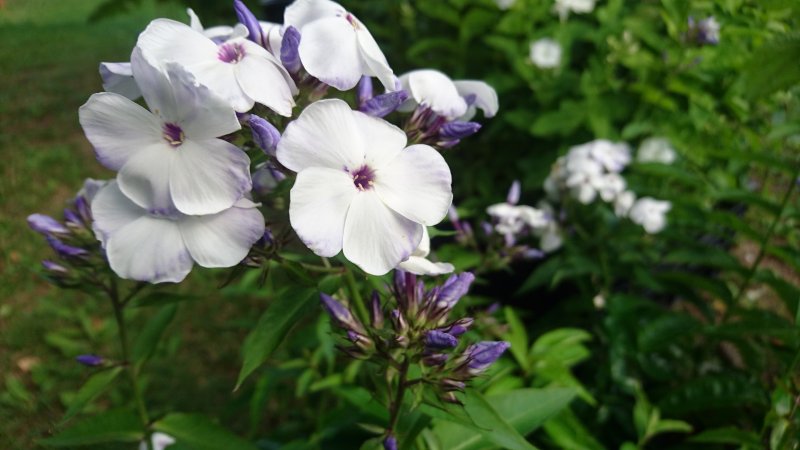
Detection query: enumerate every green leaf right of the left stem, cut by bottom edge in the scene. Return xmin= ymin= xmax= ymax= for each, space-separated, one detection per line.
xmin=153 ymin=413 xmax=258 ymax=450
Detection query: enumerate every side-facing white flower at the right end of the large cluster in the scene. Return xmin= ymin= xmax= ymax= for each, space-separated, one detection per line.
xmin=398 ymin=69 xmax=499 ymax=120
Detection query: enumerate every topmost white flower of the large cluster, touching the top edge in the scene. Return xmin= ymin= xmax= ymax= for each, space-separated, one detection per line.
xmin=283 ymin=0 xmax=395 ymax=91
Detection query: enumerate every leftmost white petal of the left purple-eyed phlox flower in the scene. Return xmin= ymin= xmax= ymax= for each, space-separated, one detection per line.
xmin=78 ymin=92 xmax=163 ymax=170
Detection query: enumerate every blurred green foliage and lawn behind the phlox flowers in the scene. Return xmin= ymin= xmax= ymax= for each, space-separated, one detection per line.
xmin=0 ymin=0 xmax=800 ymax=449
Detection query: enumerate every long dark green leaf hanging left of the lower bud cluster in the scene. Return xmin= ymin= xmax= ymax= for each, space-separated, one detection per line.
xmin=236 ymin=288 xmax=317 ymax=389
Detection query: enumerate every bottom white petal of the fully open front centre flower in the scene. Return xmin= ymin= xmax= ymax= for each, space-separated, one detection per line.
xmin=344 ymin=190 xmax=423 ymax=275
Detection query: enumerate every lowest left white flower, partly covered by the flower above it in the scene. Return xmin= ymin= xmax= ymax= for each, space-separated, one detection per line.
xmin=92 ymin=181 xmax=264 ymax=283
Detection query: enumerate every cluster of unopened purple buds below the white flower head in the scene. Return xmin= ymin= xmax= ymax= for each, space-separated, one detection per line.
xmin=322 ymin=270 xmax=509 ymax=403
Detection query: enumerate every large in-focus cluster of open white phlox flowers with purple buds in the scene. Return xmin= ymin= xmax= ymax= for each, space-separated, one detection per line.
xmin=32 ymin=0 xmax=498 ymax=283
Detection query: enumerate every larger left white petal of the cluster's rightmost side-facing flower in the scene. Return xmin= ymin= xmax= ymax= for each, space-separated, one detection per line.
xmin=401 ymin=69 xmax=467 ymax=119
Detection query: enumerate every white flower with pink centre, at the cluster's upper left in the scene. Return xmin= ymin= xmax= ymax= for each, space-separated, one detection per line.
xmin=136 ymin=19 xmax=297 ymax=117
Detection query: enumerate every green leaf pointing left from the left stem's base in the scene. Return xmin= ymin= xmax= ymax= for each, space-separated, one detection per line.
xmin=39 ymin=410 xmax=144 ymax=447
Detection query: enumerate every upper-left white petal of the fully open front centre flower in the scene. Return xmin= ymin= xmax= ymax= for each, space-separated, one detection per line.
xmin=277 ymin=99 xmax=364 ymax=172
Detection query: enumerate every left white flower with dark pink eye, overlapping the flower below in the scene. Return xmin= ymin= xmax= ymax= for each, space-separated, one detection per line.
xmin=78 ymin=49 xmax=251 ymax=214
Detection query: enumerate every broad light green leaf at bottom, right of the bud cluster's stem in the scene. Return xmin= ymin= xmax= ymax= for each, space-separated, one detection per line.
xmin=434 ymin=388 xmax=576 ymax=450
